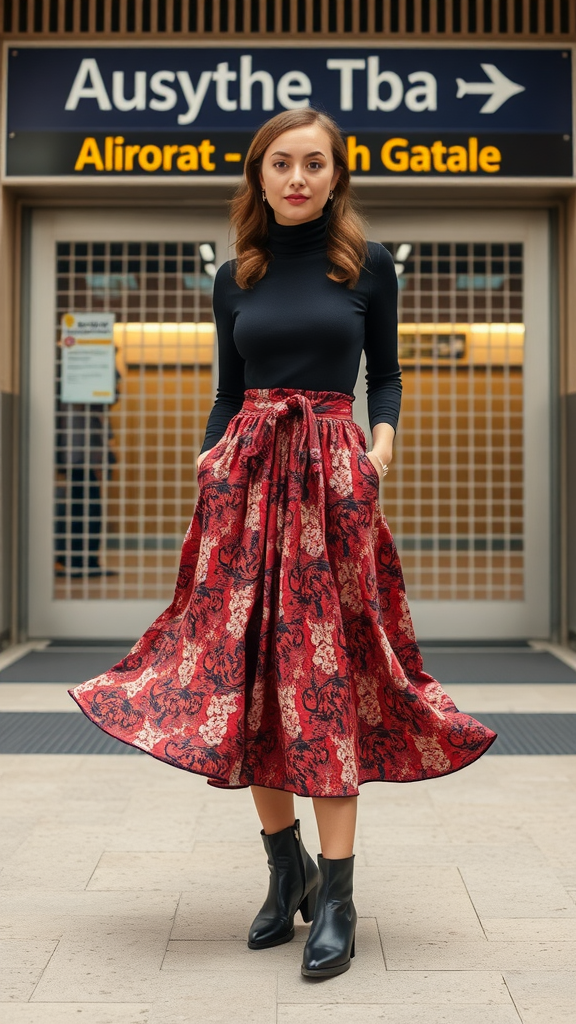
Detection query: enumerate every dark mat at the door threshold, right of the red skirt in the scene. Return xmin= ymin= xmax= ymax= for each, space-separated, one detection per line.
xmin=416 ymin=644 xmax=576 ymax=690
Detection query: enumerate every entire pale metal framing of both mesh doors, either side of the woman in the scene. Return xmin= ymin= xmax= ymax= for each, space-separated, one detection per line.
xmin=23 ymin=204 xmax=552 ymax=640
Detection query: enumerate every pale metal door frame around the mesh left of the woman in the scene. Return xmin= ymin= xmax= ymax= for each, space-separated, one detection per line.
xmin=23 ymin=204 xmax=234 ymax=640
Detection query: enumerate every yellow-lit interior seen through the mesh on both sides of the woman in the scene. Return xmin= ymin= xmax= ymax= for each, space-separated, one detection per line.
xmin=54 ymin=234 xmax=524 ymax=600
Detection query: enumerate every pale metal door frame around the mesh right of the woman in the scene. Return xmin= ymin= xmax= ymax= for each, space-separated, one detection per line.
xmin=364 ymin=208 xmax=553 ymax=641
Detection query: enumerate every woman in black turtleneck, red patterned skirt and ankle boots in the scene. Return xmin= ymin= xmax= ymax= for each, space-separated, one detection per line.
xmin=70 ymin=108 xmax=495 ymax=977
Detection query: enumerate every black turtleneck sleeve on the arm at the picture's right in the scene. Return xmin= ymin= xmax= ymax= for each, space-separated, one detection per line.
xmin=364 ymin=243 xmax=402 ymax=430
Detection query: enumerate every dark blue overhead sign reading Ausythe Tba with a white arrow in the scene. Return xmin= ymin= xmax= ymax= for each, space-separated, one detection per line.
xmin=5 ymin=46 xmax=573 ymax=180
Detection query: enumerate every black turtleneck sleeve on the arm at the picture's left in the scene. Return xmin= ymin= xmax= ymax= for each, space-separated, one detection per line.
xmin=200 ymin=262 xmax=245 ymax=455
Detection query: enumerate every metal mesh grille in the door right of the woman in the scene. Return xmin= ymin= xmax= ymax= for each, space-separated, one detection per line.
xmin=384 ymin=243 xmax=524 ymax=601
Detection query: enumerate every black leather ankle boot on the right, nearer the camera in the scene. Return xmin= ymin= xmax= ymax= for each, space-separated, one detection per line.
xmin=302 ymin=854 xmax=358 ymax=978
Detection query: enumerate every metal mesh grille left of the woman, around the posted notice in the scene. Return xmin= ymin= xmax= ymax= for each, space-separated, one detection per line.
xmin=53 ymin=242 xmax=215 ymax=600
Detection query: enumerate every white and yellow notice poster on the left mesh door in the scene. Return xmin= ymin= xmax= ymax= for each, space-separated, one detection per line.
xmin=60 ymin=312 xmax=116 ymax=406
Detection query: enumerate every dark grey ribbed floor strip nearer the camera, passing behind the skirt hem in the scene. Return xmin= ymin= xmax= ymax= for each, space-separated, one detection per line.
xmin=0 ymin=712 xmax=576 ymax=755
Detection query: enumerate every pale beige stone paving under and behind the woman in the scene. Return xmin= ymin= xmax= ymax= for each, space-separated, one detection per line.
xmin=0 ymin=643 xmax=576 ymax=1024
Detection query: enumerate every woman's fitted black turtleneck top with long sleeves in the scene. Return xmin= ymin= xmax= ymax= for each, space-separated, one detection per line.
xmin=200 ymin=206 xmax=402 ymax=453
